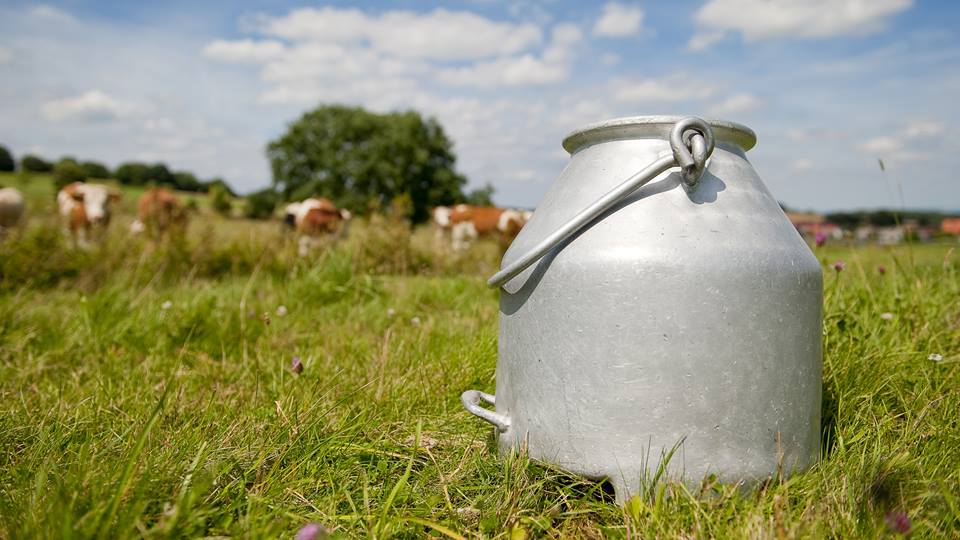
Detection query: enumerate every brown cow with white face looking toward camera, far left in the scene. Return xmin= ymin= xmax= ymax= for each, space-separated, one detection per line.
xmin=57 ymin=182 xmax=122 ymax=248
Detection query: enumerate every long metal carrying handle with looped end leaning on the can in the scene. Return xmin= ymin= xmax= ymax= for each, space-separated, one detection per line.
xmin=487 ymin=116 xmax=714 ymax=287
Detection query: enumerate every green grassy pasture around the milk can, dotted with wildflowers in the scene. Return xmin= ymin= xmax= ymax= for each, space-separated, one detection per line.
xmin=0 ymin=185 xmax=960 ymax=538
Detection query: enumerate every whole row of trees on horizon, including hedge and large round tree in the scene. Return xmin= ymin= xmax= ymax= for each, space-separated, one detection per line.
xmin=0 ymin=105 xmax=494 ymax=223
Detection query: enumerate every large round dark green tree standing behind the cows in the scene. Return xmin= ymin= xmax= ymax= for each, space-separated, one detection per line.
xmin=267 ymin=106 xmax=466 ymax=222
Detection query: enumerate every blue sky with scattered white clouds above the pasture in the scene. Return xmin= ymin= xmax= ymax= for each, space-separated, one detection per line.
xmin=0 ymin=0 xmax=960 ymax=211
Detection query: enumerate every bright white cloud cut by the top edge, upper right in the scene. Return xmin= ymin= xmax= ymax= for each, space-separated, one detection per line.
xmin=694 ymin=0 xmax=913 ymax=41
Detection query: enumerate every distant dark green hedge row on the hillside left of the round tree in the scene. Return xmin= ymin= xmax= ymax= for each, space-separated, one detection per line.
xmin=0 ymin=146 xmax=236 ymax=197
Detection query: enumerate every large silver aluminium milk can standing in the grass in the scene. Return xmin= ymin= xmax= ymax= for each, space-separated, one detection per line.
xmin=461 ymin=116 xmax=822 ymax=502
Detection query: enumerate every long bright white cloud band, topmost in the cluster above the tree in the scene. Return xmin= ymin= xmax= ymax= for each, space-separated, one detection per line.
xmin=260 ymin=7 xmax=542 ymax=60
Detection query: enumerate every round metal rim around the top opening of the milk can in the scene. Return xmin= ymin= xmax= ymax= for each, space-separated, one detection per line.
xmin=563 ymin=116 xmax=757 ymax=154
